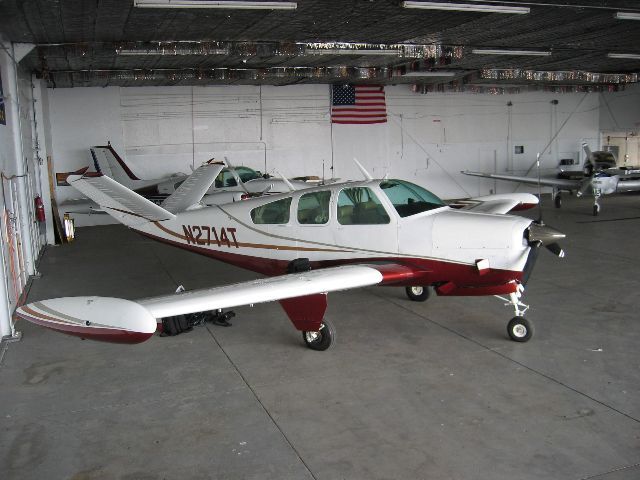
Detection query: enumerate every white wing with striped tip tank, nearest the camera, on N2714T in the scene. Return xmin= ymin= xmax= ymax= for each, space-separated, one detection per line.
xmin=16 ymin=265 xmax=385 ymax=343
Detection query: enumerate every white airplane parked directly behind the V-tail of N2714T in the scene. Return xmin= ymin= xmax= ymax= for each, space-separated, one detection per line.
xmin=60 ymin=143 xmax=314 ymax=214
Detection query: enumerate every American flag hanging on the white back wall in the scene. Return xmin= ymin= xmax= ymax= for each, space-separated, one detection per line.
xmin=331 ymin=85 xmax=387 ymax=123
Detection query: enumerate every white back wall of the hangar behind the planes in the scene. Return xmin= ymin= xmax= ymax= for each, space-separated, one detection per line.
xmin=49 ymin=85 xmax=600 ymax=224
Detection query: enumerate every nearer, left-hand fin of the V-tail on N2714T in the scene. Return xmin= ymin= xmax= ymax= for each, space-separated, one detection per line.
xmin=67 ymin=171 xmax=175 ymax=227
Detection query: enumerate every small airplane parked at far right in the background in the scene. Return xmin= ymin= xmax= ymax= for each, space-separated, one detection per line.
xmin=462 ymin=143 xmax=640 ymax=215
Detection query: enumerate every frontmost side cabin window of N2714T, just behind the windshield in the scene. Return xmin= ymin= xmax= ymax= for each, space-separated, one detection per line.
xmin=338 ymin=187 xmax=390 ymax=225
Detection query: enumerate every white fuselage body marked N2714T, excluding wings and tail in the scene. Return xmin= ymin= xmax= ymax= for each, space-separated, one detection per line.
xmin=124 ymin=181 xmax=531 ymax=282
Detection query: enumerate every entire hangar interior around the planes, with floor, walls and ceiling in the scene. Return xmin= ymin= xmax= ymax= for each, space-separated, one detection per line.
xmin=0 ymin=0 xmax=640 ymax=480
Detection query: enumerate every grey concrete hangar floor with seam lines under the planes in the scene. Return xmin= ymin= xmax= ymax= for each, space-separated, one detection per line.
xmin=0 ymin=195 xmax=640 ymax=480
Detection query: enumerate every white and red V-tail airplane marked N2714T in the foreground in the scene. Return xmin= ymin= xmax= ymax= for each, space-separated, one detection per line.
xmin=16 ymin=160 xmax=564 ymax=350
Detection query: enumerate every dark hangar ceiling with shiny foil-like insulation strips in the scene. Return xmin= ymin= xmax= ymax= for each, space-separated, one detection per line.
xmin=0 ymin=0 xmax=640 ymax=88
